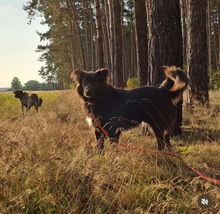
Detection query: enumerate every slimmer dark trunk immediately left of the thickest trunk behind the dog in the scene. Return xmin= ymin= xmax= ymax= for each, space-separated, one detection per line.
xmin=134 ymin=0 xmax=148 ymax=86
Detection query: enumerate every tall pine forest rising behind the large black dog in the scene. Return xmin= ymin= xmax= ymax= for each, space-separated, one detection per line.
xmin=23 ymin=0 xmax=220 ymax=95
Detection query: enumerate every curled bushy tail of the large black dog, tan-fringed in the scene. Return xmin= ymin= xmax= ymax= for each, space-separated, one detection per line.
xmin=160 ymin=66 xmax=189 ymax=105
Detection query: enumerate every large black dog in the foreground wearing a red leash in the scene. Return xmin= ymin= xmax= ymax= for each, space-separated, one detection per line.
xmin=71 ymin=66 xmax=188 ymax=150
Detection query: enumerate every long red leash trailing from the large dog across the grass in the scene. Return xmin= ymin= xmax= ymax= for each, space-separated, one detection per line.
xmin=92 ymin=113 xmax=220 ymax=185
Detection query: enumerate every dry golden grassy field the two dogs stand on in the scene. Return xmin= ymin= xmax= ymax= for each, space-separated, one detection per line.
xmin=0 ymin=90 xmax=220 ymax=214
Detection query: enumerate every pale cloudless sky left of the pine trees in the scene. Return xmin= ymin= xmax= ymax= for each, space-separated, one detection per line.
xmin=0 ymin=0 xmax=48 ymax=88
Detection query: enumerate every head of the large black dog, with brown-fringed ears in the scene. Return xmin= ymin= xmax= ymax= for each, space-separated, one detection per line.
xmin=71 ymin=68 xmax=108 ymax=99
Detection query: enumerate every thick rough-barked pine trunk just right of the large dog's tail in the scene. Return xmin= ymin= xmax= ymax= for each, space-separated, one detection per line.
xmin=187 ymin=0 xmax=209 ymax=107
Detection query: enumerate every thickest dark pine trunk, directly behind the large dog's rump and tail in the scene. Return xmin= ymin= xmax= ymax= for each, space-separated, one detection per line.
xmin=147 ymin=0 xmax=183 ymax=135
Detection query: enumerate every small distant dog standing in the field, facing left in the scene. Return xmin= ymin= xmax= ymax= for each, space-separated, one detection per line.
xmin=13 ymin=90 xmax=43 ymax=115
